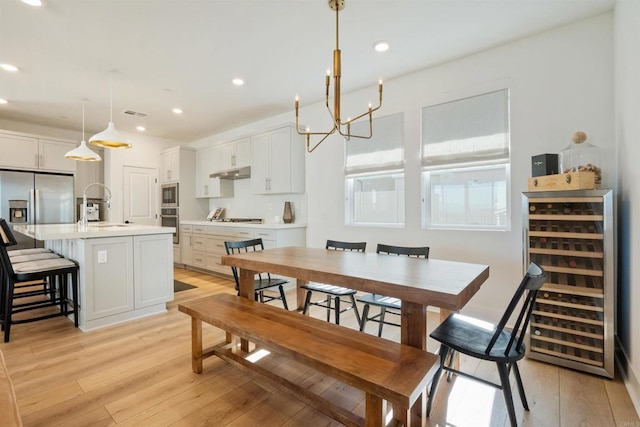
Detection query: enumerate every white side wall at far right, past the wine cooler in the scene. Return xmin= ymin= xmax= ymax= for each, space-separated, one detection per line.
xmin=615 ymin=0 xmax=640 ymax=412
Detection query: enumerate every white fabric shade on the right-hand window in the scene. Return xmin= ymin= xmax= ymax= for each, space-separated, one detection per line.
xmin=422 ymin=89 xmax=509 ymax=169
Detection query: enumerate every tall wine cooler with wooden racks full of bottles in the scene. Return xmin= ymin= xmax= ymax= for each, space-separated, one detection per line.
xmin=523 ymin=190 xmax=615 ymax=378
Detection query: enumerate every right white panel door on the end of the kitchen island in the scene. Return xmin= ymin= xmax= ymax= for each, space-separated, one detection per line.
xmin=133 ymin=234 xmax=173 ymax=309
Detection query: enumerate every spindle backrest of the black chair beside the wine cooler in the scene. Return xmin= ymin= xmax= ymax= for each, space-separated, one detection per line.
xmin=486 ymin=262 xmax=547 ymax=356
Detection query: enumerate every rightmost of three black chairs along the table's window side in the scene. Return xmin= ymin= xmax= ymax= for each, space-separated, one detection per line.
xmin=358 ymin=244 xmax=429 ymax=337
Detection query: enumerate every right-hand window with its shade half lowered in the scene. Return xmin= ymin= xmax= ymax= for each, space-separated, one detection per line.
xmin=422 ymin=89 xmax=510 ymax=230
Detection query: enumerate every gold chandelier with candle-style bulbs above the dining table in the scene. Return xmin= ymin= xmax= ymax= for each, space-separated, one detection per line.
xmin=296 ymin=0 xmax=382 ymax=153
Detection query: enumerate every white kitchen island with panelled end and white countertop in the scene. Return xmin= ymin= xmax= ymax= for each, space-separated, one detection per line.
xmin=14 ymin=223 xmax=175 ymax=331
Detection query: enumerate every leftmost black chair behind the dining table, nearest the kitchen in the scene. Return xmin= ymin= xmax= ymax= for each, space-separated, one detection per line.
xmin=224 ymin=238 xmax=289 ymax=310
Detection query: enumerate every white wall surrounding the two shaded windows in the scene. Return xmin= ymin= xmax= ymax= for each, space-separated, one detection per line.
xmin=193 ymin=14 xmax=615 ymax=319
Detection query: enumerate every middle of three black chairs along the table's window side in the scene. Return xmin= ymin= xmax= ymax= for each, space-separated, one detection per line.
xmin=301 ymin=240 xmax=367 ymax=325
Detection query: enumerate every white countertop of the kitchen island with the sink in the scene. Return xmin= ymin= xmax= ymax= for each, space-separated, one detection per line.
xmin=13 ymin=222 xmax=176 ymax=240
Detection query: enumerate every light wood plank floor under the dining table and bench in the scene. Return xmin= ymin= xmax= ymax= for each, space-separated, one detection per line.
xmin=0 ymin=269 xmax=640 ymax=427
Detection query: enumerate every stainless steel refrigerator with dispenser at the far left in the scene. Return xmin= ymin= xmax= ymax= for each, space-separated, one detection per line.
xmin=0 ymin=170 xmax=75 ymax=249
